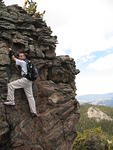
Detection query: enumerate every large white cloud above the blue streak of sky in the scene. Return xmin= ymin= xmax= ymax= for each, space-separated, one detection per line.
xmin=38 ymin=0 xmax=113 ymax=59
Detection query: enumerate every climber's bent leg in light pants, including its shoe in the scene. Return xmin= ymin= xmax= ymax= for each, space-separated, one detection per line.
xmin=4 ymin=78 xmax=26 ymax=105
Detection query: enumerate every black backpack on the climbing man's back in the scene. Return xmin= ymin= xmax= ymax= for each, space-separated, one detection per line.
xmin=25 ymin=60 xmax=39 ymax=81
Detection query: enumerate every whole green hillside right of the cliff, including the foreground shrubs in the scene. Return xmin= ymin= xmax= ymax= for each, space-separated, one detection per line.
xmin=73 ymin=104 xmax=113 ymax=150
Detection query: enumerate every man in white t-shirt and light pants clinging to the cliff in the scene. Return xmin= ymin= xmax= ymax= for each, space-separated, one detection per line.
xmin=4 ymin=48 xmax=37 ymax=117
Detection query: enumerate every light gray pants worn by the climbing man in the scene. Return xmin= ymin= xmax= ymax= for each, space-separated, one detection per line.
xmin=7 ymin=78 xmax=36 ymax=113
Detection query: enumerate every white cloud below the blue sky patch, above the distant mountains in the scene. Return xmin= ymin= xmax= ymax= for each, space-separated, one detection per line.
xmin=77 ymin=54 xmax=113 ymax=95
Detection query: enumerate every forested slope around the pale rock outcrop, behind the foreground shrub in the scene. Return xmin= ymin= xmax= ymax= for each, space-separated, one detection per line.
xmin=77 ymin=104 xmax=113 ymax=136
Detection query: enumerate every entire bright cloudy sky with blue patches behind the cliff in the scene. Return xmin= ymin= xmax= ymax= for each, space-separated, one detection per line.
xmin=5 ymin=0 xmax=113 ymax=96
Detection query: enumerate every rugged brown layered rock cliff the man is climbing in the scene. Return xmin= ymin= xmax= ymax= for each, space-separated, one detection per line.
xmin=0 ymin=1 xmax=79 ymax=150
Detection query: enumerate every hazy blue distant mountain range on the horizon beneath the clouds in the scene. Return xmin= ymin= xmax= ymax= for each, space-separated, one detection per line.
xmin=77 ymin=93 xmax=113 ymax=107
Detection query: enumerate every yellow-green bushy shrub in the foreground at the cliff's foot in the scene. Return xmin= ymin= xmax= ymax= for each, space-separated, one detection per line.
xmin=73 ymin=128 xmax=110 ymax=150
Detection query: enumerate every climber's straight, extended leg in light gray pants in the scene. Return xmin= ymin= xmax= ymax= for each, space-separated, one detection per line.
xmin=24 ymin=80 xmax=37 ymax=114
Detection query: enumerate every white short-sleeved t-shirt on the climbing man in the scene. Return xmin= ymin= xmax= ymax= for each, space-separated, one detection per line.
xmin=16 ymin=59 xmax=27 ymax=75
